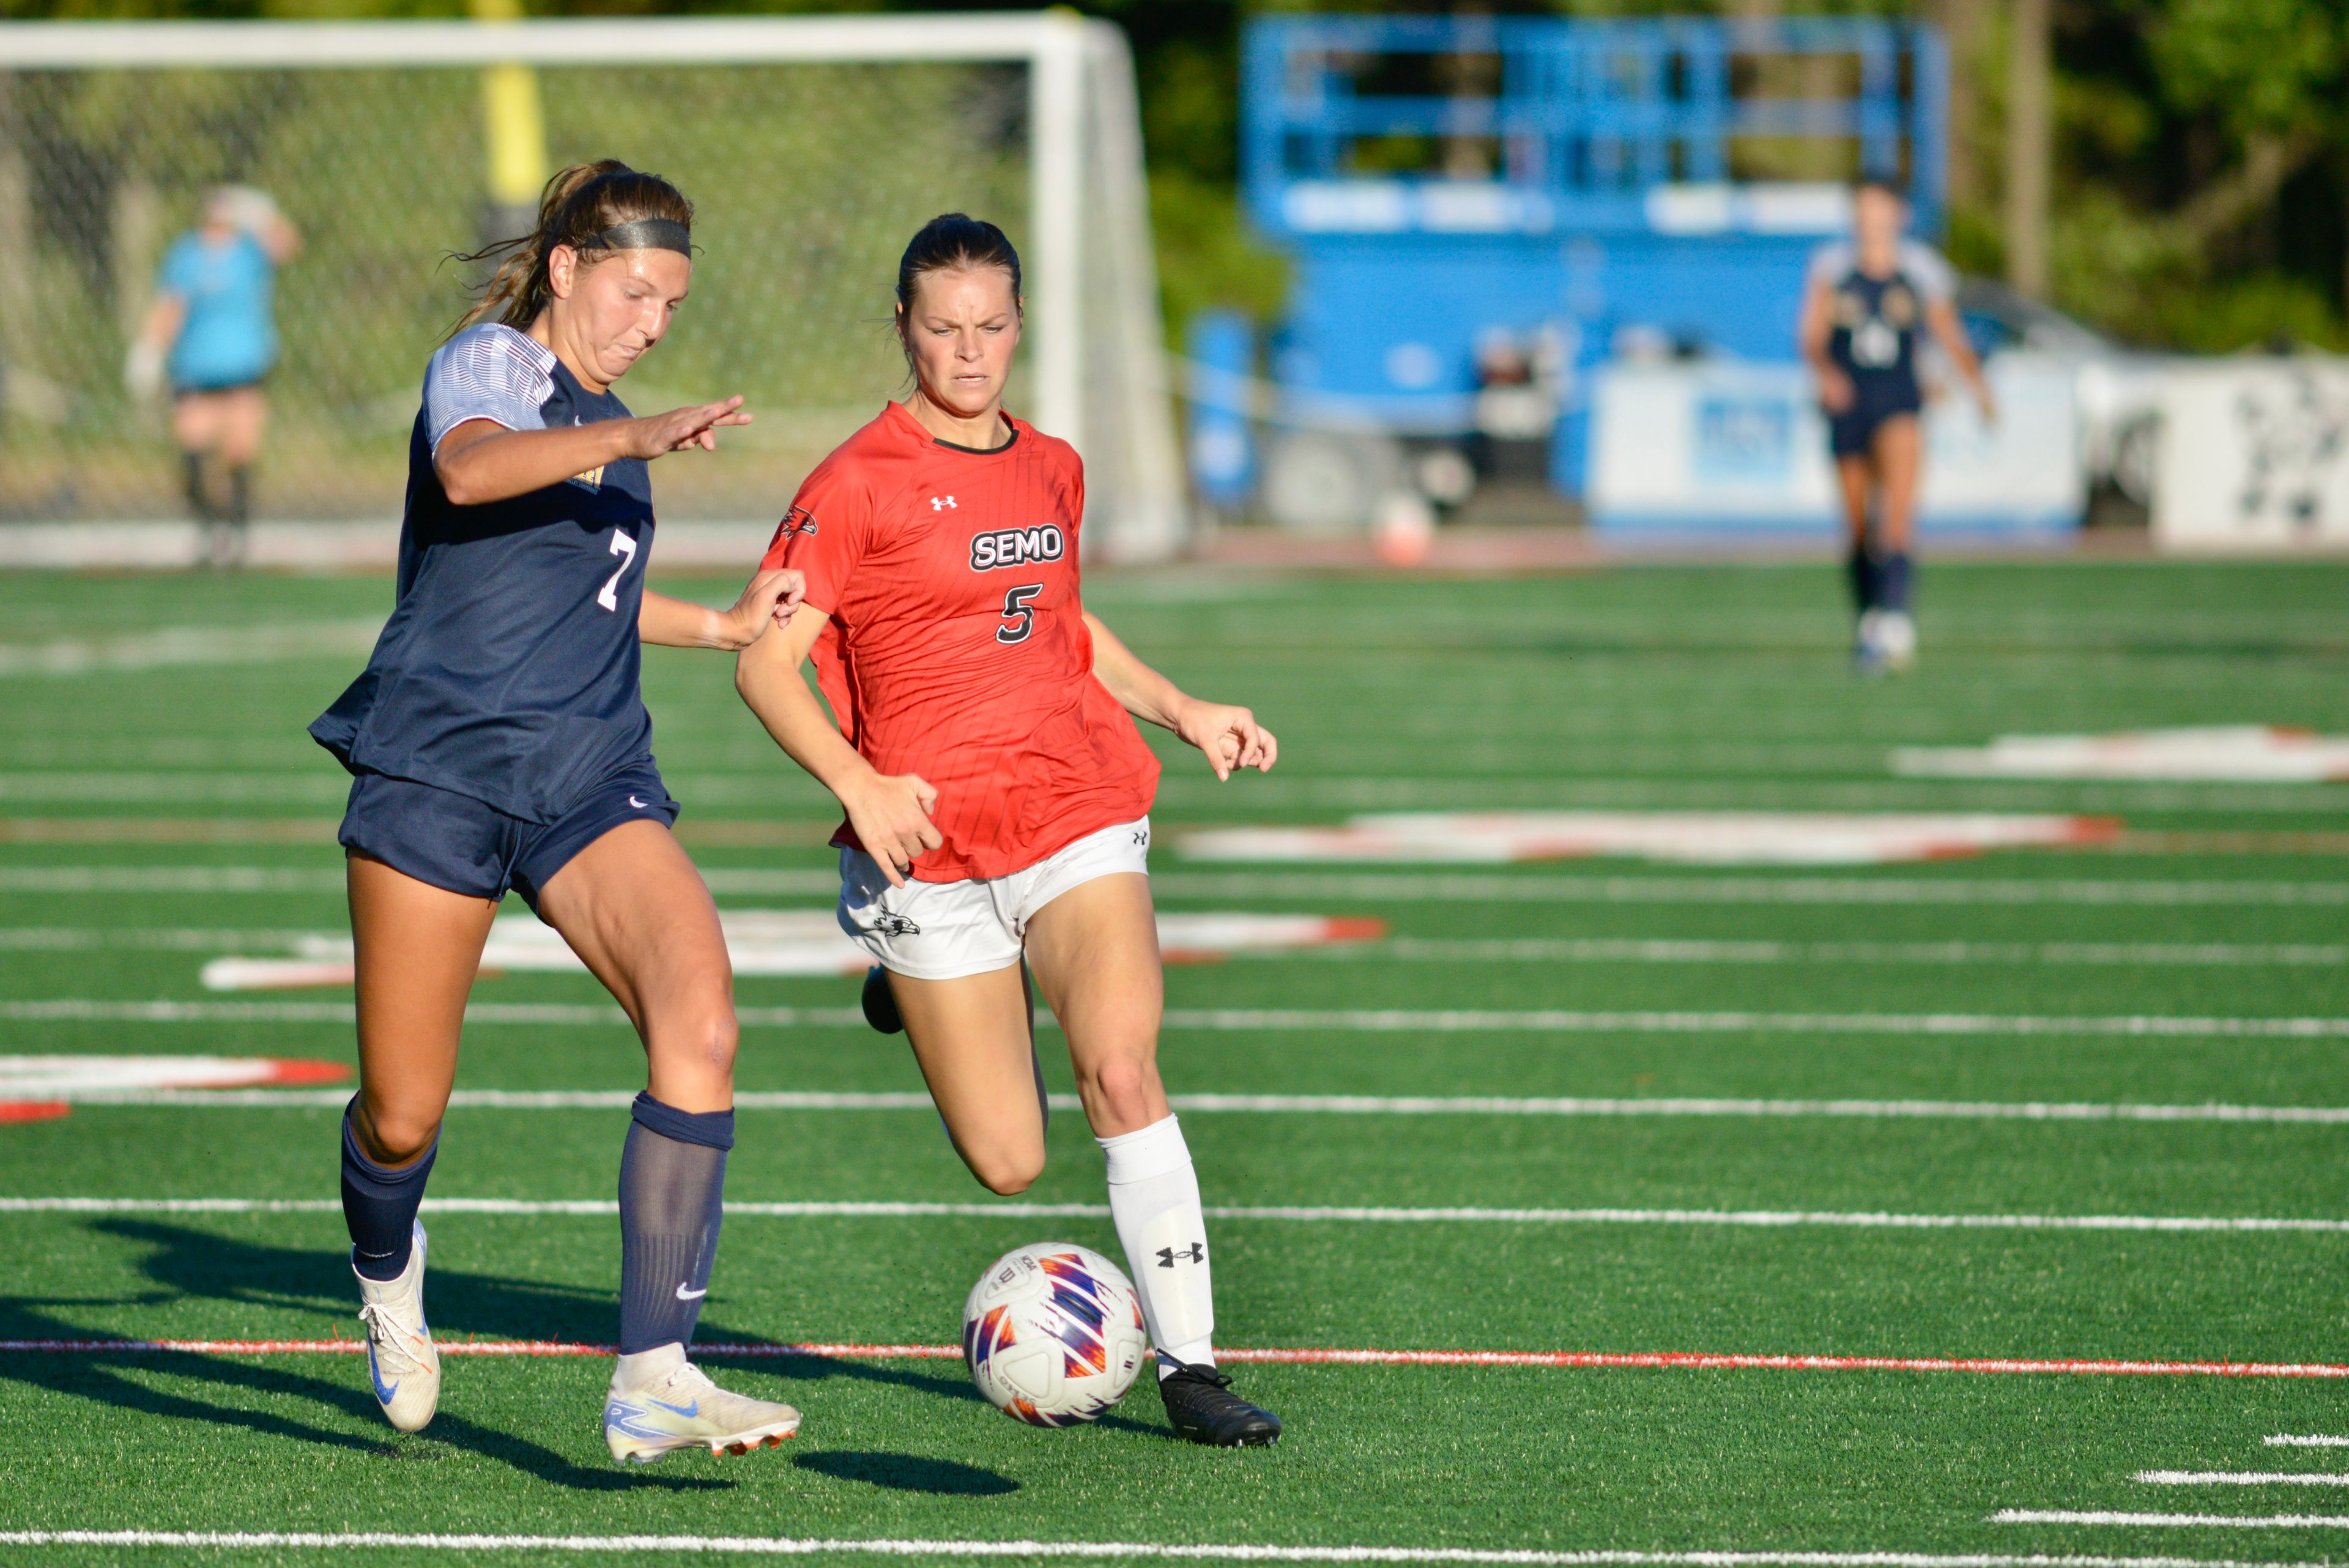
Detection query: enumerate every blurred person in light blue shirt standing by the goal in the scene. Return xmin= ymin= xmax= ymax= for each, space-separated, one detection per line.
xmin=125 ymin=186 xmax=301 ymax=567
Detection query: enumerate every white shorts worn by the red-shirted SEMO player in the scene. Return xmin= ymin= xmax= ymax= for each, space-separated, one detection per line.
xmin=841 ymin=818 xmax=1151 ymax=980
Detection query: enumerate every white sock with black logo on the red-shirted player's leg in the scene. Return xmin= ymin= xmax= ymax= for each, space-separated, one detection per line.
xmin=1094 ymin=1117 xmax=1214 ymax=1378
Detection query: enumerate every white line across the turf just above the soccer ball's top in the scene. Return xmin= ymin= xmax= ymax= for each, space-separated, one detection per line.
xmin=0 ymin=1197 xmax=2349 ymax=1234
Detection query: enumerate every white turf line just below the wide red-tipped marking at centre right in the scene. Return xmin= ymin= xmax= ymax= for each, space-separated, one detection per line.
xmin=0 ymin=865 xmax=2349 ymax=907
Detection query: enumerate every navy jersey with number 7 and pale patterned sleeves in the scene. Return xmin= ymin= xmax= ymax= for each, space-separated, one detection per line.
xmin=310 ymin=324 xmax=653 ymax=823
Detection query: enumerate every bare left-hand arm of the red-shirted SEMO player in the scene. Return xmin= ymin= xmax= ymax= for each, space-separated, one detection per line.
xmin=735 ymin=609 xmax=947 ymax=886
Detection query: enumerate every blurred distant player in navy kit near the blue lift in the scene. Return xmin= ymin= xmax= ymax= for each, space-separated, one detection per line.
xmin=1799 ymin=179 xmax=1997 ymax=672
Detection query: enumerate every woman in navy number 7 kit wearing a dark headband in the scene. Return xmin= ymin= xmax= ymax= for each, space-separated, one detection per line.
xmin=310 ymin=160 xmax=801 ymax=1460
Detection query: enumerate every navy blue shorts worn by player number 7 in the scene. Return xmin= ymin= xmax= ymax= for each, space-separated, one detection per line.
xmin=336 ymin=762 xmax=677 ymax=910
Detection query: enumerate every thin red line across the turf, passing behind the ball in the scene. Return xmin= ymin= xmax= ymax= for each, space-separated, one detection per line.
xmin=0 ymin=1340 xmax=2349 ymax=1378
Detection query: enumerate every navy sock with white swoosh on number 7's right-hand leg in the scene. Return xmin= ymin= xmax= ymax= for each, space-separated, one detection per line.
xmin=620 ymin=1093 xmax=733 ymax=1356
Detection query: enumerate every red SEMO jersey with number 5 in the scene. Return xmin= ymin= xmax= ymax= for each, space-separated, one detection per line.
xmin=761 ymin=402 xmax=1158 ymax=882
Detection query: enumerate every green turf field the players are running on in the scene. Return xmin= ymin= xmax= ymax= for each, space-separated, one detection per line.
xmin=0 ymin=562 xmax=2349 ymax=1563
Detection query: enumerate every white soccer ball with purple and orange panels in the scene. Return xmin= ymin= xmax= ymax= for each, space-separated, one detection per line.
xmin=963 ymin=1241 xmax=1146 ymax=1427
